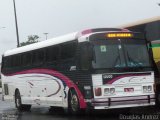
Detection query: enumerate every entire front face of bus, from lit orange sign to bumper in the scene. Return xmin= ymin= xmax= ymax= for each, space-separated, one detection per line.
xmin=79 ymin=31 xmax=155 ymax=109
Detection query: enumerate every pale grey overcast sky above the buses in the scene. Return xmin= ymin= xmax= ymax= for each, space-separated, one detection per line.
xmin=0 ymin=0 xmax=160 ymax=61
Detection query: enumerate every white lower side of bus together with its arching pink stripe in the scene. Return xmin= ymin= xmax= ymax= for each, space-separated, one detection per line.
xmin=3 ymin=69 xmax=89 ymax=108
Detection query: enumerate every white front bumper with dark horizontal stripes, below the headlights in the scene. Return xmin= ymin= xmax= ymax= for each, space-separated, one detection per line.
xmin=91 ymin=95 xmax=155 ymax=109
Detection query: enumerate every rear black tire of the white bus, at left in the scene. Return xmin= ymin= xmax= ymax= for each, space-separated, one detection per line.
xmin=15 ymin=90 xmax=31 ymax=111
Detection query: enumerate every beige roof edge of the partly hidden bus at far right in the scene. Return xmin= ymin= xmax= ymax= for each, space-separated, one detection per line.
xmin=119 ymin=16 xmax=160 ymax=28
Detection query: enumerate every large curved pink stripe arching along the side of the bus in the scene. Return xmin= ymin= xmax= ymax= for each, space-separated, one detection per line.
xmin=5 ymin=69 xmax=86 ymax=108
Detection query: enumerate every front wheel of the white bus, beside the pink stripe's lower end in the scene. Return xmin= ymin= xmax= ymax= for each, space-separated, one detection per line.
xmin=68 ymin=90 xmax=80 ymax=115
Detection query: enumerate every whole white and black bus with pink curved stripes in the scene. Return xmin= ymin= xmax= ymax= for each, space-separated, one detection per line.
xmin=2 ymin=28 xmax=155 ymax=114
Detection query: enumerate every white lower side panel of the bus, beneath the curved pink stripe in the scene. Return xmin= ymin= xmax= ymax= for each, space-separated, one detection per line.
xmin=2 ymin=70 xmax=64 ymax=106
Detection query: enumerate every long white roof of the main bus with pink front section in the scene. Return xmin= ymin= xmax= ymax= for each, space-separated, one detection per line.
xmin=3 ymin=28 xmax=127 ymax=56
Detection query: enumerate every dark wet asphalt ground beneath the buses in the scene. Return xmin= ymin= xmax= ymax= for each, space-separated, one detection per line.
xmin=0 ymin=94 xmax=160 ymax=120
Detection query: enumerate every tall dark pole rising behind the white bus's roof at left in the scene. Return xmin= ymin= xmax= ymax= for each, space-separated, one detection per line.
xmin=13 ymin=0 xmax=20 ymax=47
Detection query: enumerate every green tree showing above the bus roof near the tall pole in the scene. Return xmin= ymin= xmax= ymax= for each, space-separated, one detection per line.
xmin=20 ymin=35 xmax=39 ymax=46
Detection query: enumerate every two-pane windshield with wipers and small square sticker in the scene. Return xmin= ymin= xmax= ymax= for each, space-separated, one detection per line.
xmin=92 ymin=39 xmax=151 ymax=69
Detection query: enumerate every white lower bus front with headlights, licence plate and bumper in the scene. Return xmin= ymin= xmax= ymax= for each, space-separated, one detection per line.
xmin=92 ymin=72 xmax=155 ymax=109
